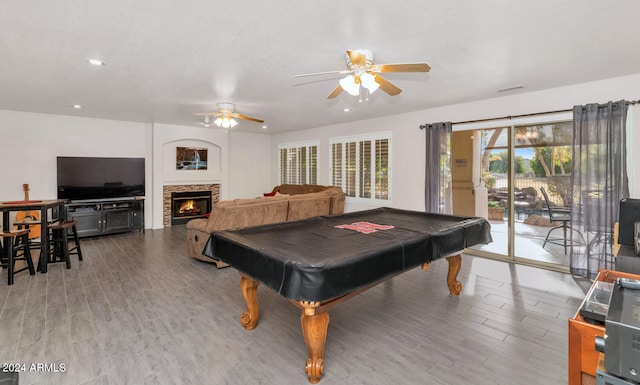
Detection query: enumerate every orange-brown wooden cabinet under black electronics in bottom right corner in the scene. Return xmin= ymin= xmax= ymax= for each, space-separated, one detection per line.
xmin=569 ymin=270 xmax=640 ymax=385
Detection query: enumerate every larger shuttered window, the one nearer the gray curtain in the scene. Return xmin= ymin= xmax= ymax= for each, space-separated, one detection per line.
xmin=329 ymin=132 xmax=391 ymax=204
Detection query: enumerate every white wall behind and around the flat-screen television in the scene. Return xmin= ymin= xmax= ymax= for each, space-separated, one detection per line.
xmin=0 ymin=110 xmax=151 ymax=230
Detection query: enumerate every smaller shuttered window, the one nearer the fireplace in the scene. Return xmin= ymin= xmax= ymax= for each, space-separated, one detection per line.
xmin=278 ymin=142 xmax=318 ymax=184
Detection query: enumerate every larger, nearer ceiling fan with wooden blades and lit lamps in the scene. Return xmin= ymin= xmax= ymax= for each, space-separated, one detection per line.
xmin=294 ymin=49 xmax=431 ymax=99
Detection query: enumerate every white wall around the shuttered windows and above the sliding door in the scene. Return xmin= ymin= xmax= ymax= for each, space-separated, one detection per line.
xmin=271 ymin=74 xmax=640 ymax=211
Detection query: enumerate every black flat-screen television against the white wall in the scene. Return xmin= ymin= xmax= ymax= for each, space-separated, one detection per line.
xmin=57 ymin=156 xmax=145 ymax=201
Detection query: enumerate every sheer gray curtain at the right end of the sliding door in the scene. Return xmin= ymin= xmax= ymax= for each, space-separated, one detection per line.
xmin=570 ymin=100 xmax=629 ymax=279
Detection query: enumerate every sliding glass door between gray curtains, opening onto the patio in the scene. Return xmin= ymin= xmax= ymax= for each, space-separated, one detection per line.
xmin=464 ymin=121 xmax=579 ymax=270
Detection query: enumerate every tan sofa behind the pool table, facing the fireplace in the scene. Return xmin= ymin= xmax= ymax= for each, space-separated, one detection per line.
xmin=187 ymin=185 xmax=344 ymax=268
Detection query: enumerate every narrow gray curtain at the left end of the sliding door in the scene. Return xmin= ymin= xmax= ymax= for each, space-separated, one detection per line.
xmin=421 ymin=122 xmax=452 ymax=214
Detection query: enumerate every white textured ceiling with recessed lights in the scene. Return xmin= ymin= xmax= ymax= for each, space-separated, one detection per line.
xmin=0 ymin=0 xmax=640 ymax=133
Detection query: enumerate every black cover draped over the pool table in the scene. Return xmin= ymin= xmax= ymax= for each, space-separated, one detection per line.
xmin=203 ymin=208 xmax=492 ymax=302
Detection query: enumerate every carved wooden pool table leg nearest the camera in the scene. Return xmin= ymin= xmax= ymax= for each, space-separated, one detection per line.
xmin=300 ymin=301 xmax=329 ymax=384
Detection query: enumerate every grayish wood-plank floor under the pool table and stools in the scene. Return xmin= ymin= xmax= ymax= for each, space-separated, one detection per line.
xmin=0 ymin=226 xmax=588 ymax=385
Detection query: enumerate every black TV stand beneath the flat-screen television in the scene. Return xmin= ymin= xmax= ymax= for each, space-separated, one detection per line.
xmin=64 ymin=197 xmax=144 ymax=237
